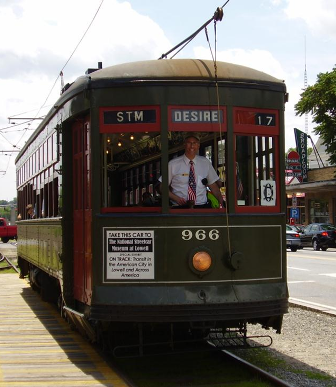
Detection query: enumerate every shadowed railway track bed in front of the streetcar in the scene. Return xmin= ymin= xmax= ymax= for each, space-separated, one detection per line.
xmin=111 ymin=342 xmax=293 ymax=387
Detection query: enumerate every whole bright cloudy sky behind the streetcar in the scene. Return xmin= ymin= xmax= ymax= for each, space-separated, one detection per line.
xmin=0 ymin=0 xmax=336 ymax=200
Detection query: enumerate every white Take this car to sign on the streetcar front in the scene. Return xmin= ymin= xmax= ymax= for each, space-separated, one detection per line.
xmin=105 ymin=229 xmax=154 ymax=280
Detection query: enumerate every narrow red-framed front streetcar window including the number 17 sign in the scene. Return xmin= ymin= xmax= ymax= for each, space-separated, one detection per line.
xmin=234 ymin=108 xmax=280 ymax=212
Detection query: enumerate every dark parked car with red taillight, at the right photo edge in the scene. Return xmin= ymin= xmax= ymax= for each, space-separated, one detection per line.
xmin=301 ymin=223 xmax=336 ymax=251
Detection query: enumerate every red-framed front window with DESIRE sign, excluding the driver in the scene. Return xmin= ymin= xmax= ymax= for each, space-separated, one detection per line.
xmin=168 ymin=105 xmax=227 ymax=212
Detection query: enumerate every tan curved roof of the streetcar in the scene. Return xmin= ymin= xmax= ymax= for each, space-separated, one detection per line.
xmin=16 ymin=59 xmax=286 ymax=161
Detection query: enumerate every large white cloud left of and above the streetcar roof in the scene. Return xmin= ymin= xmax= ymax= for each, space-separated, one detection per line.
xmin=0 ymin=0 xmax=172 ymax=199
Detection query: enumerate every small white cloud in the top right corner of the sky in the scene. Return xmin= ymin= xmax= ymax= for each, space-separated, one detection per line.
xmin=285 ymin=0 xmax=336 ymax=39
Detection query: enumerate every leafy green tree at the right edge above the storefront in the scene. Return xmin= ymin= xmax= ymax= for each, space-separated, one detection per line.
xmin=295 ymin=67 xmax=336 ymax=165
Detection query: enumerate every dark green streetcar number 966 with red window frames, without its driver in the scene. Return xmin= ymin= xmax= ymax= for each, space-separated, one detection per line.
xmin=16 ymin=59 xmax=288 ymax=354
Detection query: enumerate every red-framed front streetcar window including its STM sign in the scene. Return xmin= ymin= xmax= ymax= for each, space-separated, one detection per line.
xmin=100 ymin=106 xmax=161 ymax=212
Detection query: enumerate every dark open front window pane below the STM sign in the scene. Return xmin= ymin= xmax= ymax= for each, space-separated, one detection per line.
xmin=101 ymin=131 xmax=161 ymax=210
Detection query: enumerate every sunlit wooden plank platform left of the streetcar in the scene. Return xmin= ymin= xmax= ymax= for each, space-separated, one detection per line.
xmin=0 ymin=274 xmax=127 ymax=387
